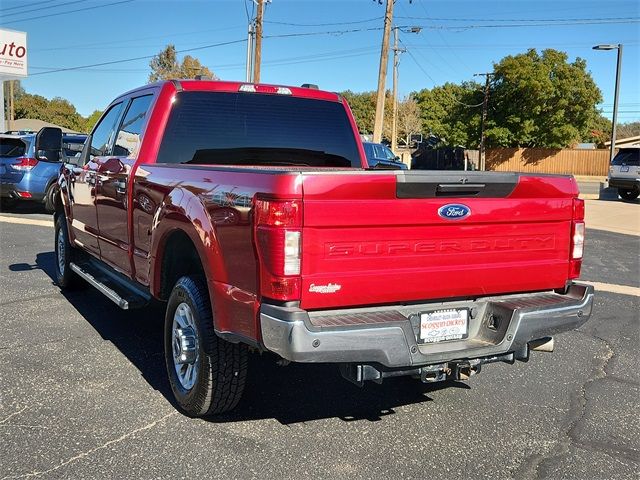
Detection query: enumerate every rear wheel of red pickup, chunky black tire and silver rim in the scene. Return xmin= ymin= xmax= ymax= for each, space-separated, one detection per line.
xmin=164 ymin=276 xmax=248 ymax=417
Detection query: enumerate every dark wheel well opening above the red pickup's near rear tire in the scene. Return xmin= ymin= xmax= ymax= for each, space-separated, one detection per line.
xmin=160 ymin=230 xmax=204 ymax=300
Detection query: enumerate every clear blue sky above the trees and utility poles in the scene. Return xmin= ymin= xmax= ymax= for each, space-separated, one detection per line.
xmin=0 ymin=0 xmax=640 ymax=122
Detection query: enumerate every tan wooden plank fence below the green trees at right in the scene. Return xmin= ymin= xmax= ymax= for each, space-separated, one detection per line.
xmin=486 ymin=148 xmax=609 ymax=176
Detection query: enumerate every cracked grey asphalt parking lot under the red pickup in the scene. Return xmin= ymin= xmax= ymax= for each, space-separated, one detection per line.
xmin=0 ymin=202 xmax=640 ymax=479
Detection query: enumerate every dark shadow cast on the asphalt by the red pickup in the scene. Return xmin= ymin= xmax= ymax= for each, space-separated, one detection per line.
xmin=21 ymin=252 xmax=470 ymax=425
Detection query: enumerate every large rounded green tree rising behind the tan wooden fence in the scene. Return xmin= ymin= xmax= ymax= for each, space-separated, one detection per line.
xmin=486 ymin=49 xmax=602 ymax=148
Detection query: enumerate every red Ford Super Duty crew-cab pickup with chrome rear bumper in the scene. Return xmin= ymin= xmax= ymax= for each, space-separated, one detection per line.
xmin=55 ymin=80 xmax=593 ymax=416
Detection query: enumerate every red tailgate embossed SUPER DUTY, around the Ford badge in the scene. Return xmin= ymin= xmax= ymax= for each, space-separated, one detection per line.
xmin=301 ymin=171 xmax=578 ymax=309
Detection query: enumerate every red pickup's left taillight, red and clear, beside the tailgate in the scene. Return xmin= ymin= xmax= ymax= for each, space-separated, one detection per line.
xmin=254 ymin=198 xmax=302 ymax=301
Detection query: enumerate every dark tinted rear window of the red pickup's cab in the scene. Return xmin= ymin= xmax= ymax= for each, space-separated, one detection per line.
xmin=157 ymin=92 xmax=361 ymax=168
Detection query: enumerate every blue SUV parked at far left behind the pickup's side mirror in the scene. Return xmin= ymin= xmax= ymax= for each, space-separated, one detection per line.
xmin=0 ymin=129 xmax=86 ymax=211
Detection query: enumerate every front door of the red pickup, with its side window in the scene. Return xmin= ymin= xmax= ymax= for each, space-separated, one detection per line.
xmin=69 ymin=103 xmax=122 ymax=256
